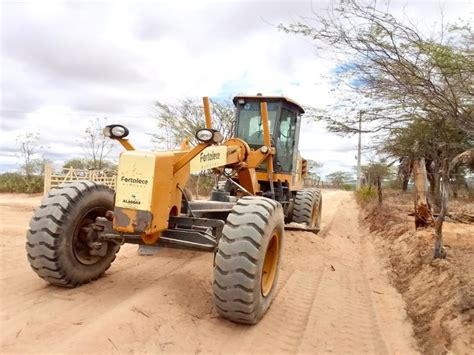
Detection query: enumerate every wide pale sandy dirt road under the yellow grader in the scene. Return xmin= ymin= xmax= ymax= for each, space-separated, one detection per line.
xmin=0 ymin=191 xmax=416 ymax=354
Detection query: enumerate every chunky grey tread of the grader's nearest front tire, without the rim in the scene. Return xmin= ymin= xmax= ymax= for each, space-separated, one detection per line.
xmin=213 ymin=196 xmax=283 ymax=324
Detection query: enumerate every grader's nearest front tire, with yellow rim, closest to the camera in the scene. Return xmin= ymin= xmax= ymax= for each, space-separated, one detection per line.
xmin=213 ymin=197 xmax=284 ymax=324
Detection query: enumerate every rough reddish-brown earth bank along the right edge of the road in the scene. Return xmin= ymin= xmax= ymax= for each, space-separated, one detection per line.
xmin=361 ymin=190 xmax=474 ymax=354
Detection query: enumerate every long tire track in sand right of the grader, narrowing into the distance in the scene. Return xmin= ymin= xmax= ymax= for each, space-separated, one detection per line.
xmin=298 ymin=195 xmax=398 ymax=354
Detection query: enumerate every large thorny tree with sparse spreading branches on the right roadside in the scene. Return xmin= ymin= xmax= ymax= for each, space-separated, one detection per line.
xmin=280 ymin=0 xmax=474 ymax=258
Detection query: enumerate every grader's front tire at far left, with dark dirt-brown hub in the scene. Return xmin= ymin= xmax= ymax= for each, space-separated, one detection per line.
xmin=26 ymin=181 xmax=120 ymax=287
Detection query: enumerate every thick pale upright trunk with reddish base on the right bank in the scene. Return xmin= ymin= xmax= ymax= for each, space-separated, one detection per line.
xmin=413 ymin=158 xmax=433 ymax=228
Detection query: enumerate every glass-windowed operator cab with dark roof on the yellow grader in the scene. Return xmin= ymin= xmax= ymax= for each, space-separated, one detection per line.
xmin=233 ymin=95 xmax=304 ymax=173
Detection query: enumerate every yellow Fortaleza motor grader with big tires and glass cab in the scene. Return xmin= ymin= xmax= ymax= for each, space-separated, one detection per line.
xmin=26 ymin=95 xmax=322 ymax=324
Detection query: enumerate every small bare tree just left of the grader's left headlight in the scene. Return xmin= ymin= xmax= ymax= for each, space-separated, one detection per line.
xmin=80 ymin=118 xmax=114 ymax=170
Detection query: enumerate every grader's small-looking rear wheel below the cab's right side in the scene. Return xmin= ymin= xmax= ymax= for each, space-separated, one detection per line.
xmin=291 ymin=189 xmax=323 ymax=231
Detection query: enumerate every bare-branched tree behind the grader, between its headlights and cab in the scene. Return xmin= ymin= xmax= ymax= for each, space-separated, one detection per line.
xmin=153 ymin=97 xmax=235 ymax=149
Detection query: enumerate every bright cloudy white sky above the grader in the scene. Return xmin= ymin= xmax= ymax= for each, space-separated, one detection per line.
xmin=0 ymin=0 xmax=473 ymax=175
